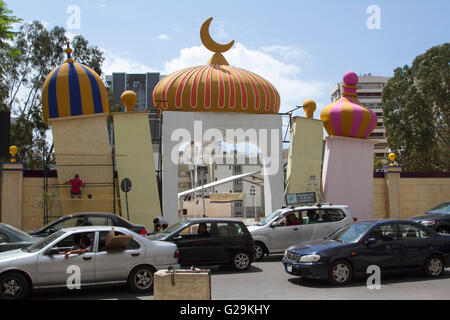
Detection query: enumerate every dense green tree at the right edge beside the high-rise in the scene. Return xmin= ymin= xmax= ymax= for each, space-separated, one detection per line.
xmin=383 ymin=43 xmax=450 ymax=172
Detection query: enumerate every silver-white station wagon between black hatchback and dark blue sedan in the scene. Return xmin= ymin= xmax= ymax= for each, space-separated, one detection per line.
xmin=248 ymin=204 xmax=356 ymax=260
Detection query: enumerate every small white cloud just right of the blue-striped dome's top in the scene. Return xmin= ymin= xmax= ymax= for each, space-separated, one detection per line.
xmin=102 ymin=49 xmax=156 ymax=74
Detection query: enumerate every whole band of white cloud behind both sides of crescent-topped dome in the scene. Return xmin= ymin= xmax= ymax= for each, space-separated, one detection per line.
xmin=102 ymin=43 xmax=333 ymax=118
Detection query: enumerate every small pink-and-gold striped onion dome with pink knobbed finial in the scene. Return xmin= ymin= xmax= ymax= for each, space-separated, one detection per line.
xmin=320 ymin=71 xmax=377 ymax=139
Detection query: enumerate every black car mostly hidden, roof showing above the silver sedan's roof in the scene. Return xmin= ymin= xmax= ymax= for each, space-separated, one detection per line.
xmin=28 ymin=212 xmax=147 ymax=237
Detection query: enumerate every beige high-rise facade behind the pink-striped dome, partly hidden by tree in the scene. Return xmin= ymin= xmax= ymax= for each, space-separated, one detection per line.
xmin=331 ymin=74 xmax=390 ymax=159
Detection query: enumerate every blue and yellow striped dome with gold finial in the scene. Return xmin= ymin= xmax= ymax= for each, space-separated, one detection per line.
xmin=42 ymin=43 xmax=109 ymax=122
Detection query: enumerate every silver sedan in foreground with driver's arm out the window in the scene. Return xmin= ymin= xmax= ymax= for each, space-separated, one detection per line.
xmin=0 ymin=226 xmax=180 ymax=300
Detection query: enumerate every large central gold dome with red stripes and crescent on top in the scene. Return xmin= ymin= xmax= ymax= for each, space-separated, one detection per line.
xmin=153 ymin=18 xmax=280 ymax=114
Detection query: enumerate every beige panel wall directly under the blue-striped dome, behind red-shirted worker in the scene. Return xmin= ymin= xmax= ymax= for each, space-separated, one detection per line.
xmin=49 ymin=114 xmax=114 ymax=215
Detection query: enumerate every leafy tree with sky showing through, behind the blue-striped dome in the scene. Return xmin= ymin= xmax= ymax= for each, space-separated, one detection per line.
xmin=5 ymin=21 xmax=104 ymax=169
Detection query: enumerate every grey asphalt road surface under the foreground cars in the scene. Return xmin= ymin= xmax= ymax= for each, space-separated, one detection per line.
xmin=29 ymin=255 xmax=450 ymax=300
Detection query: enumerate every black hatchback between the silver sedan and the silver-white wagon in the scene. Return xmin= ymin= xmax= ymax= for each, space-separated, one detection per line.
xmin=149 ymin=218 xmax=255 ymax=271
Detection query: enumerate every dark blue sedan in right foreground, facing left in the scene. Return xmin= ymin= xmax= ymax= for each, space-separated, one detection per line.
xmin=283 ymin=220 xmax=450 ymax=285
